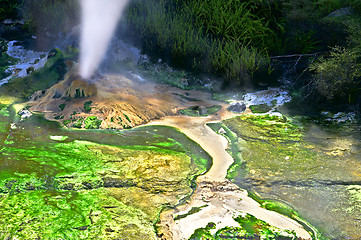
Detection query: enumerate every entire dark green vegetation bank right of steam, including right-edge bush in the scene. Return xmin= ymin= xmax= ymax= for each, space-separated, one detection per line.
xmin=126 ymin=0 xmax=361 ymax=112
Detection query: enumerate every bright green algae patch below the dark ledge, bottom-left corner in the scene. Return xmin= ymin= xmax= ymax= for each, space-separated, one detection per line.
xmin=0 ymin=190 xmax=155 ymax=239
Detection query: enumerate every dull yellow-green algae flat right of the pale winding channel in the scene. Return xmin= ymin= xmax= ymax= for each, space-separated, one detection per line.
xmin=221 ymin=115 xmax=361 ymax=239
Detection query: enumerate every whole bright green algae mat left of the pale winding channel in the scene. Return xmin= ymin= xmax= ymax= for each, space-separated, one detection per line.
xmin=0 ymin=108 xmax=211 ymax=239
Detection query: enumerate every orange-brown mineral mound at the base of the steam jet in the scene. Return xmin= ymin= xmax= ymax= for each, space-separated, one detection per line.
xmin=30 ymin=62 xmax=220 ymax=129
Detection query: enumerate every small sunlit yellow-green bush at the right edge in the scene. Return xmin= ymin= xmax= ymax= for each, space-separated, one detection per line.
xmin=310 ymin=47 xmax=361 ymax=102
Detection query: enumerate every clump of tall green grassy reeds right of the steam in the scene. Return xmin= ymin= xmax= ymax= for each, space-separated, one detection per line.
xmin=127 ymin=0 xmax=275 ymax=83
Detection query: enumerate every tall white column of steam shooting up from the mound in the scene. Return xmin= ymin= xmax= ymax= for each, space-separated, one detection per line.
xmin=79 ymin=0 xmax=128 ymax=78
